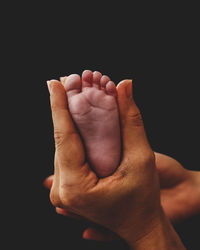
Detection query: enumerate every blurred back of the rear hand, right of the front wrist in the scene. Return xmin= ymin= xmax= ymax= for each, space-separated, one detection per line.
xmin=155 ymin=153 xmax=200 ymax=223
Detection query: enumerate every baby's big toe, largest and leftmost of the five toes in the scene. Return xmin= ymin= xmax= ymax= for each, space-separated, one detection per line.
xmin=64 ymin=74 xmax=81 ymax=97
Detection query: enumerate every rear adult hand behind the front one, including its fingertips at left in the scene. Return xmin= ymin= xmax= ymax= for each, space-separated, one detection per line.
xmin=44 ymin=153 xmax=200 ymax=241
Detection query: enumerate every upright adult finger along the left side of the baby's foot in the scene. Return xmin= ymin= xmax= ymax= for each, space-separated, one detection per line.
xmin=48 ymin=80 xmax=85 ymax=176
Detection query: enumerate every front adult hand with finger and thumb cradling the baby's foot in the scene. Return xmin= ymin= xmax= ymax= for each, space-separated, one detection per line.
xmin=46 ymin=80 xmax=184 ymax=250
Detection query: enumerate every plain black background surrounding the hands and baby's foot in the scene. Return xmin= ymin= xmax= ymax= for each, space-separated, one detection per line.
xmin=1 ymin=2 xmax=200 ymax=250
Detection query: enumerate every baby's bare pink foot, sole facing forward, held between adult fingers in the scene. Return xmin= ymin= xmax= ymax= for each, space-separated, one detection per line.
xmin=64 ymin=70 xmax=121 ymax=177
